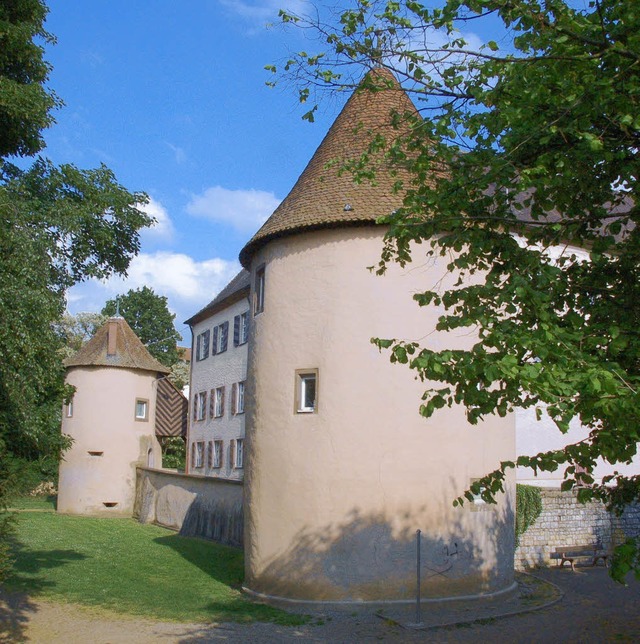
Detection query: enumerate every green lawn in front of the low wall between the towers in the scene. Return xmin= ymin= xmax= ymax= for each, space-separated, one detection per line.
xmin=4 ymin=512 xmax=307 ymax=625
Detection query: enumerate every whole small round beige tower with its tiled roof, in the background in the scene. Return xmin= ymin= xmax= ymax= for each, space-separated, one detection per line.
xmin=58 ymin=317 xmax=169 ymax=516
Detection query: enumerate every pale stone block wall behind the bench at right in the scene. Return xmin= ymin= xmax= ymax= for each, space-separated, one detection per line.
xmin=515 ymin=488 xmax=640 ymax=569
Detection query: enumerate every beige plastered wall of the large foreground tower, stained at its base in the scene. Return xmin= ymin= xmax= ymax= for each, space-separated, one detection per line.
xmin=245 ymin=227 xmax=515 ymax=601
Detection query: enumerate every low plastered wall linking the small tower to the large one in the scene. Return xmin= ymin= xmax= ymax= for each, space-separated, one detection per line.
xmin=133 ymin=467 xmax=243 ymax=547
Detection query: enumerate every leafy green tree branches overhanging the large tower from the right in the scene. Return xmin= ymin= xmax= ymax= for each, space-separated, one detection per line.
xmin=269 ymin=0 xmax=640 ymax=578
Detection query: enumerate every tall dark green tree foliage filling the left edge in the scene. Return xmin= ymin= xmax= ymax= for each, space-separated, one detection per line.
xmin=0 ymin=0 xmax=152 ymax=570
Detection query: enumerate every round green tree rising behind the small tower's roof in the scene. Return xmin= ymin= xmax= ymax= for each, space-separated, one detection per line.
xmin=102 ymin=286 xmax=180 ymax=367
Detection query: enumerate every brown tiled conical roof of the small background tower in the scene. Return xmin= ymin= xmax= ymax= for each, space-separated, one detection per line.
xmin=64 ymin=318 xmax=170 ymax=373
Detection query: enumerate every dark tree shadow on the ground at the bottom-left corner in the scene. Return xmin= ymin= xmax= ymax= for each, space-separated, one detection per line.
xmin=0 ymin=540 xmax=86 ymax=642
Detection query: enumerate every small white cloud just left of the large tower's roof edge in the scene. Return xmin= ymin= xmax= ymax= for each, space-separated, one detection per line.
xmin=187 ymin=186 xmax=280 ymax=232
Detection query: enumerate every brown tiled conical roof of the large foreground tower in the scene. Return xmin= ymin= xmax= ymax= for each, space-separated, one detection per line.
xmin=240 ymin=69 xmax=417 ymax=268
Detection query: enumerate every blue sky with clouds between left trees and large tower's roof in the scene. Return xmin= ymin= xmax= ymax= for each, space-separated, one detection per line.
xmin=46 ymin=0 xmax=342 ymax=342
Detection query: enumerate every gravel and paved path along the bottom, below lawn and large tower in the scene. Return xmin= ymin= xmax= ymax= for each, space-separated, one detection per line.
xmin=0 ymin=568 xmax=640 ymax=644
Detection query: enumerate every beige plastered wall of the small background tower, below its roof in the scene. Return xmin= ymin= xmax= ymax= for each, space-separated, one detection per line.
xmin=58 ymin=367 xmax=162 ymax=516
